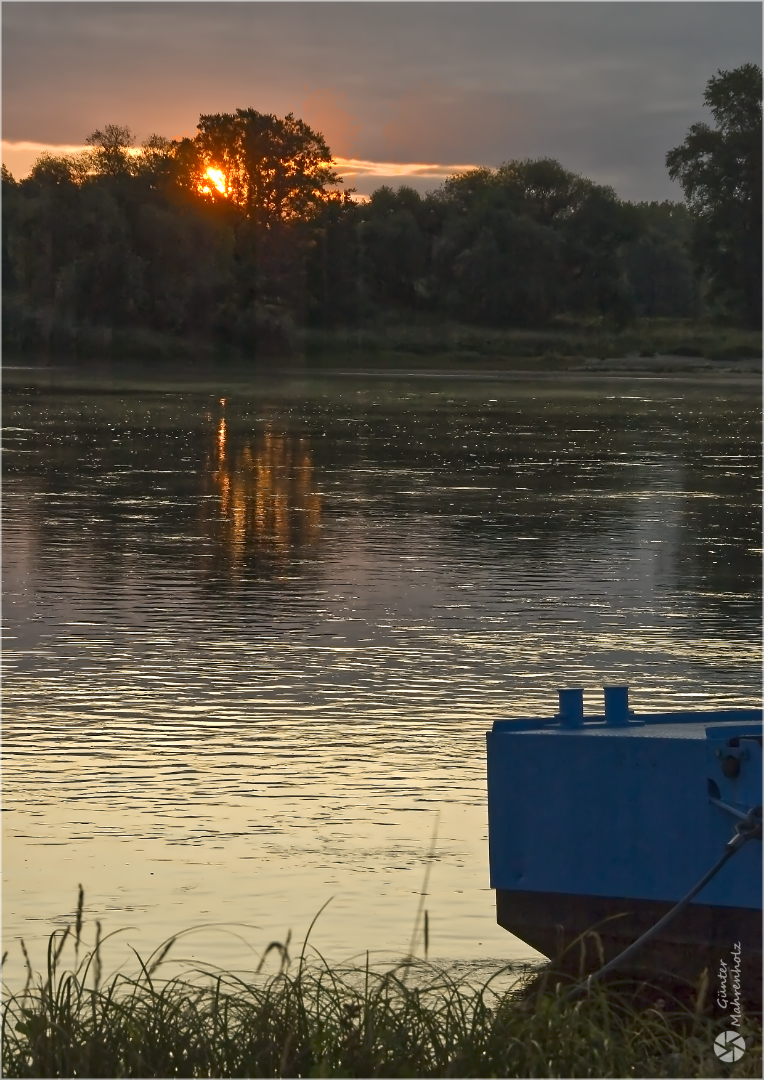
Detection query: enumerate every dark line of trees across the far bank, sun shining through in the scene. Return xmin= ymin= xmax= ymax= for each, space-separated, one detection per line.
xmin=2 ymin=65 xmax=762 ymax=351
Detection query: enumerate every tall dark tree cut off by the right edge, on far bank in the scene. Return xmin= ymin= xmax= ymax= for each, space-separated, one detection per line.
xmin=666 ymin=64 xmax=762 ymax=325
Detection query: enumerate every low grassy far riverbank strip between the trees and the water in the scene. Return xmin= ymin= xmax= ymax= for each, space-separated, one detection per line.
xmin=5 ymin=319 xmax=762 ymax=376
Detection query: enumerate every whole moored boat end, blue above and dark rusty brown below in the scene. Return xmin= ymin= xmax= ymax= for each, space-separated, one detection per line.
xmin=487 ymin=687 xmax=762 ymax=1008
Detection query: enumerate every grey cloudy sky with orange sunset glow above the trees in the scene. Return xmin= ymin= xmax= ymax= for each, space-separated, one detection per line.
xmin=2 ymin=0 xmax=762 ymax=200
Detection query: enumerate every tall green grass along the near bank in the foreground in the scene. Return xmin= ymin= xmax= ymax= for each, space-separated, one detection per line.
xmin=2 ymin=906 xmax=762 ymax=1077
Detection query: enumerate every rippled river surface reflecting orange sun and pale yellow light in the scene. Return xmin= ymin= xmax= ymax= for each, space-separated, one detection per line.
xmin=3 ymin=376 xmax=761 ymax=980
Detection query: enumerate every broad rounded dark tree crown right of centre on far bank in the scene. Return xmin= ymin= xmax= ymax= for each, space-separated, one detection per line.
xmin=406 ymin=158 xmax=641 ymax=326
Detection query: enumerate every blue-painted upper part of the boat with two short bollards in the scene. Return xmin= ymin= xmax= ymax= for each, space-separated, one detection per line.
xmin=486 ymin=687 xmax=762 ymax=909
